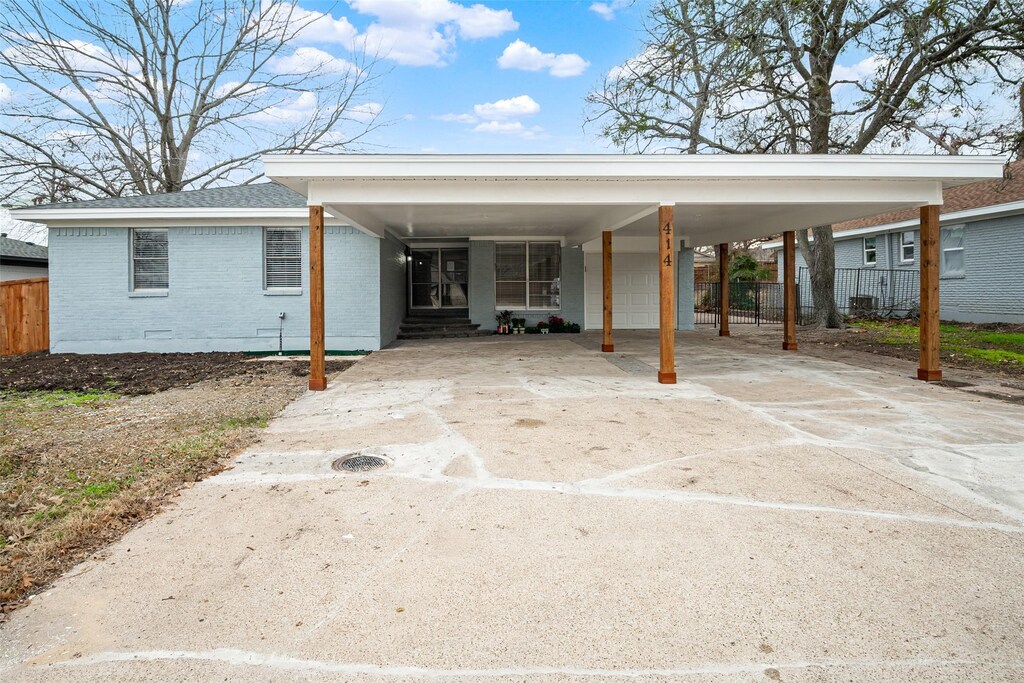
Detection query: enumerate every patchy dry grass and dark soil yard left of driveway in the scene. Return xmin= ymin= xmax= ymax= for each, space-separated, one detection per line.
xmin=0 ymin=353 xmax=351 ymax=620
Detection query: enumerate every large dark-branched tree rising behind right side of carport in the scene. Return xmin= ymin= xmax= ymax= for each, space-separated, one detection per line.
xmin=588 ymin=0 xmax=1024 ymax=327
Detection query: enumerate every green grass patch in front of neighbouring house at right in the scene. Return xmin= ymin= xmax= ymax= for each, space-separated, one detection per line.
xmin=855 ymin=321 xmax=1024 ymax=374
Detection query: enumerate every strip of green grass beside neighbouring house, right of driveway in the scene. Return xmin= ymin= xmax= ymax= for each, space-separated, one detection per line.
xmin=857 ymin=321 xmax=1024 ymax=366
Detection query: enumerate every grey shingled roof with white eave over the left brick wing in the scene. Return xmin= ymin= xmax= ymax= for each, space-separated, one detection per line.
xmin=23 ymin=182 xmax=306 ymax=210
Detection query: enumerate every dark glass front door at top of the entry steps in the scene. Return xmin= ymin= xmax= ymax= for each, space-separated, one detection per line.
xmin=409 ymin=247 xmax=469 ymax=309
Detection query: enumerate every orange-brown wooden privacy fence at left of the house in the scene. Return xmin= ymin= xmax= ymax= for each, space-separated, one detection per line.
xmin=0 ymin=278 xmax=50 ymax=355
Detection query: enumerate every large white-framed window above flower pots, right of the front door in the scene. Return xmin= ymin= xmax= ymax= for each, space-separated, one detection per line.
xmin=495 ymin=242 xmax=562 ymax=309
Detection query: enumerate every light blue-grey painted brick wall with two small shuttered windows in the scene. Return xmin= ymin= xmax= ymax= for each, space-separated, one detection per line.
xmin=49 ymin=226 xmax=381 ymax=353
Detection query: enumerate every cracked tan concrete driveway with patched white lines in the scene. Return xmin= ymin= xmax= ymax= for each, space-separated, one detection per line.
xmin=0 ymin=333 xmax=1024 ymax=682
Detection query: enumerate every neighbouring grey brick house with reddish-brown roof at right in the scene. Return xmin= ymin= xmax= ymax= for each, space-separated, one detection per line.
xmin=767 ymin=160 xmax=1024 ymax=323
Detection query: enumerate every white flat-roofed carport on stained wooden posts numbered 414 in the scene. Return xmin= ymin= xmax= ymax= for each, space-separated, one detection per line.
xmin=264 ymin=155 xmax=1004 ymax=390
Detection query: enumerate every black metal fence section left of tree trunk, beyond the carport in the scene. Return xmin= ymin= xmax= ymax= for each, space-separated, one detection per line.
xmin=693 ymin=281 xmax=811 ymax=325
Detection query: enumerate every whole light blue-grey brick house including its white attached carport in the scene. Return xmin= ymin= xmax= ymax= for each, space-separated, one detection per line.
xmin=13 ymin=155 xmax=1002 ymax=388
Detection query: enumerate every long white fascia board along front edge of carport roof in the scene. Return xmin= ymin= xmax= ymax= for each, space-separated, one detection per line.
xmin=263 ymin=155 xmax=1005 ymax=186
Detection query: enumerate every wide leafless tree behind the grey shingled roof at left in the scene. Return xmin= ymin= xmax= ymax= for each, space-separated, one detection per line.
xmin=0 ymin=0 xmax=380 ymax=203
